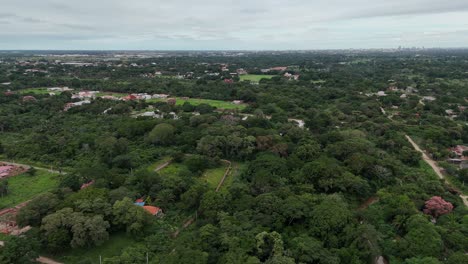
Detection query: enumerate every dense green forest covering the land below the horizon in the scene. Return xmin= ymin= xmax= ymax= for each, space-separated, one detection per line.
xmin=0 ymin=50 xmax=468 ymax=264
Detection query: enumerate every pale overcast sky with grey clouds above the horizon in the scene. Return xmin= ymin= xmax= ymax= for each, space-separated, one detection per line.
xmin=0 ymin=0 xmax=468 ymax=50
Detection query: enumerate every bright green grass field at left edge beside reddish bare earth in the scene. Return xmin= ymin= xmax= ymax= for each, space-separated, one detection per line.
xmin=0 ymin=170 xmax=59 ymax=209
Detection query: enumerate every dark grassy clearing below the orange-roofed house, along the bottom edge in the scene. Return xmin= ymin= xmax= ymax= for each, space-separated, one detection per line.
xmin=52 ymin=233 xmax=137 ymax=263
